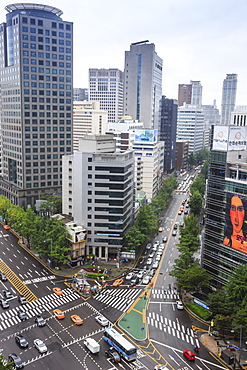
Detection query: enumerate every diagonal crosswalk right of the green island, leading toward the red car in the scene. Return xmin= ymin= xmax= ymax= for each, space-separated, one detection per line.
xmin=147 ymin=312 xmax=199 ymax=346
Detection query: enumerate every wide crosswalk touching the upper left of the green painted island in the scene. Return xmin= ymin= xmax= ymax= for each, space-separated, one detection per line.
xmin=94 ymin=289 xmax=142 ymax=312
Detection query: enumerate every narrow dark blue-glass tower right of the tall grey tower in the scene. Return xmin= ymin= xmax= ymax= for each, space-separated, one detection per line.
xmin=159 ymin=96 xmax=178 ymax=173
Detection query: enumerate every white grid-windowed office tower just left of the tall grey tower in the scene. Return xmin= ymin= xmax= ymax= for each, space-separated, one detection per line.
xmin=88 ymin=68 xmax=123 ymax=122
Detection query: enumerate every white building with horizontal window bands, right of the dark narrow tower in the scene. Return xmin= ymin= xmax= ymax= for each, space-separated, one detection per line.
xmin=177 ymin=104 xmax=204 ymax=154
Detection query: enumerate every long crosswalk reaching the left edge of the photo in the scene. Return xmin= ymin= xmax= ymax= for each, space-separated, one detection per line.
xmin=0 ymin=288 xmax=80 ymax=330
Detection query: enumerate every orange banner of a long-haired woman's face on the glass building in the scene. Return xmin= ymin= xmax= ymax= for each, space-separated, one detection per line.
xmin=223 ymin=193 xmax=247 ymax=253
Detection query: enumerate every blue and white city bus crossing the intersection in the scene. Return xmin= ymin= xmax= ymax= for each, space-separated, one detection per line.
xmin=103 ymin=328 xmax=137 ymax=361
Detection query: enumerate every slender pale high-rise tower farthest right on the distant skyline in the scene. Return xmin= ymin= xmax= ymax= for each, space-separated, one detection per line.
xmin=221 ymin=73 xmax=238 ymax=125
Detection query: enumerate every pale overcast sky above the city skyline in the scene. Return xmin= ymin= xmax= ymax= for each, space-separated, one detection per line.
xmin=0 ymin=0 xmax=247 ymax=108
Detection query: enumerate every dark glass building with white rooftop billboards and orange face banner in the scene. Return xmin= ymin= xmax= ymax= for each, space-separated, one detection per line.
xmin=202 ymin=125 xmax=247 ymax=288
